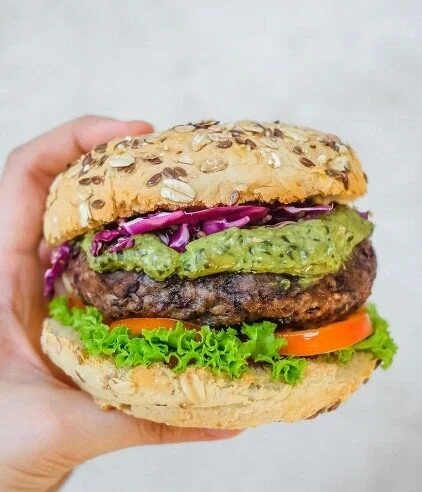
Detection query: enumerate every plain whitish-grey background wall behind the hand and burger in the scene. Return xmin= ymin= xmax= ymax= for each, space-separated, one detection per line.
xmin=0 ymin=0 xmax=422 ymax=492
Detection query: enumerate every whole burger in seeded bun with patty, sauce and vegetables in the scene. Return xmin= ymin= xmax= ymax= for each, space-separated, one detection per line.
xmin=41 ymin=120 xmax=396 ymax=429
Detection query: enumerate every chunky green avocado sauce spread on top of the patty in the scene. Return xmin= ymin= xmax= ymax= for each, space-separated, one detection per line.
xmin=82 ymin=206 xmax=373 ymax=286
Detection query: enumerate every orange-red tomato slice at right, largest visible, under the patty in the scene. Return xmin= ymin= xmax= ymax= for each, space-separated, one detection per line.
xmin=277 ymin=308 xmax=372 ymax=355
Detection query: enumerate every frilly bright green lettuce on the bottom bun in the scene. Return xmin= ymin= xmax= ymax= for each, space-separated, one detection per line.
xmin=49 ymin=297 xmax=397 ymax=385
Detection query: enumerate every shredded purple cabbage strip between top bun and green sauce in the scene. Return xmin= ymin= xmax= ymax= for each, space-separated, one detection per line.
xmin=91 ymin=204 xmax=334 ymax=256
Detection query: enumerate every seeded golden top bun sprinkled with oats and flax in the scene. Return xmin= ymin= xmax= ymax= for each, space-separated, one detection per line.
xmin=44 ymin=120 xmax=366 ymax=246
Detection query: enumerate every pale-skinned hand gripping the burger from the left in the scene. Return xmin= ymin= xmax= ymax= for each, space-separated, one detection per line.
xmin=0 ymin=116 xmax=241 ymax=491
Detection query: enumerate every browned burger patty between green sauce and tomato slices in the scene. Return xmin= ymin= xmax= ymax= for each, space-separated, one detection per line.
xmin=66 ymin=241 xmax=377 ymax=328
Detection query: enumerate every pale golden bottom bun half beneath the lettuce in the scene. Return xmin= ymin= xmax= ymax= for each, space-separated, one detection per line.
xmin=41 ymin=319 xmax=376 ymax=429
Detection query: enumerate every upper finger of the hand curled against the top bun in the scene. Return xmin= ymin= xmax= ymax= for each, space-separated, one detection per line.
xmin=0 ymin=116 xmax=153 ymax=253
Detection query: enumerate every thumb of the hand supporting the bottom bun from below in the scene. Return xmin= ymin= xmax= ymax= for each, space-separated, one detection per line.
xmin=56 ymin=390 xmax=241 ymax=467
